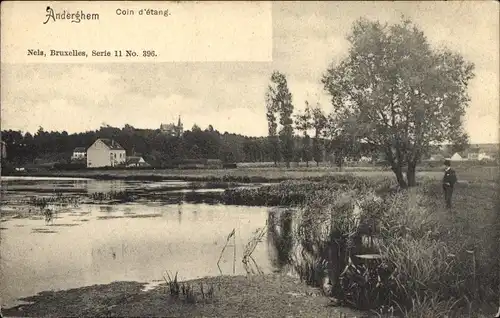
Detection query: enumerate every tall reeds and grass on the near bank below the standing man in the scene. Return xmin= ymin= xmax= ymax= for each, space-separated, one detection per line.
xmin=282 ymin=176 xmax=499 ymax=317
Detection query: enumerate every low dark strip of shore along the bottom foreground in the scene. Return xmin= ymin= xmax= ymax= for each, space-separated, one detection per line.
xmin=3 ymin=274 xmax=366 ymax=318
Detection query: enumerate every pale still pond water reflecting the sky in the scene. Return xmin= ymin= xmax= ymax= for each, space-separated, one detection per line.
xmin=0 ymin=177 xmax=282 ymax=307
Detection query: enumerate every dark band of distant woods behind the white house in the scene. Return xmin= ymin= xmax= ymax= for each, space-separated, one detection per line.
xmin=1 ymin=121 xmax=364 ymax=167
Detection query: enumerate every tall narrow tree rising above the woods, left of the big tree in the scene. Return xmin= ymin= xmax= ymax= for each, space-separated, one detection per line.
xmin=266 ymin=71 xmax=294 ymax=168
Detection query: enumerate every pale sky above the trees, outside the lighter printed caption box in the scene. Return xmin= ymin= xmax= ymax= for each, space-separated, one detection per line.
xmin=1 ymin=1 xmax=500 ymax=143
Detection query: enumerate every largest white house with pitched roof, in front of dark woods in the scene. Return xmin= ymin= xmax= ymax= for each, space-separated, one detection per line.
xmin=87 ymin=138 xmax=127 ymax=168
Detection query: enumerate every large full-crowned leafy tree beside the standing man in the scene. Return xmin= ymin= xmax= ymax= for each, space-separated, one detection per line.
xmin=322 ymin=19 xmax=474 ymax=187
